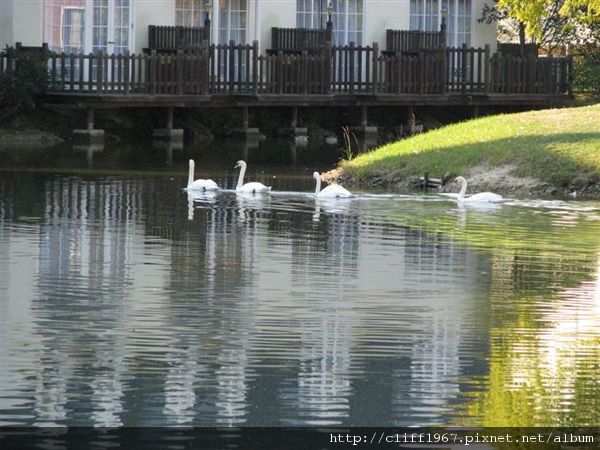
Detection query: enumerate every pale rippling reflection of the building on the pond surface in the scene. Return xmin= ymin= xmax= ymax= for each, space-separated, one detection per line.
xmin=2 ymin=173 xmax=494 ymax=425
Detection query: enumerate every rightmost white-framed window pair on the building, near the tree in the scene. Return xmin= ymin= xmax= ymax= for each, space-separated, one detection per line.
xmin=410 ymin=0 xmax=471 ymax=47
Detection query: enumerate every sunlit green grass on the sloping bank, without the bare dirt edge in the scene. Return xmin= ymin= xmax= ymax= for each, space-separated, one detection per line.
xmin=341 ymin=104 xmax=600 ymax=186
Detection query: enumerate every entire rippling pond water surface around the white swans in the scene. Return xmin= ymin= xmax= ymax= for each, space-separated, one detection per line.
xmin=0 ymin=144 xmax=600 ymax=426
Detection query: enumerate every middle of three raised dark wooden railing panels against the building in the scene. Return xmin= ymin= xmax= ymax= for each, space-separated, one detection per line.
xmin=267 ymin=24 xmax=333 ymax=54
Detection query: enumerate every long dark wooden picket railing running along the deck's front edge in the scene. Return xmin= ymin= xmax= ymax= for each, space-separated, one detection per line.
xmin=45 ymin=41 xmax=572 ymax=95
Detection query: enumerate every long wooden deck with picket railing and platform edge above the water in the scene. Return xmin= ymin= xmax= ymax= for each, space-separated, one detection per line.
xmin=0 ymin=41 xmax=572 ymax=108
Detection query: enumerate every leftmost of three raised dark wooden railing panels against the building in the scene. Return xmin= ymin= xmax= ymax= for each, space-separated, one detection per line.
xmin=148 ymin=22 xmax=210 ymax=52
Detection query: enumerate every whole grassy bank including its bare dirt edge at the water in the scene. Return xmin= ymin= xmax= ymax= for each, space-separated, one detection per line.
xmin=336 ymin=104 xmax=600 ymax=198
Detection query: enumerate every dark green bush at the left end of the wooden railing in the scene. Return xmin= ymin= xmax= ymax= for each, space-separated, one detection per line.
xmin=0 ymin=47 xmax=49 ymax=121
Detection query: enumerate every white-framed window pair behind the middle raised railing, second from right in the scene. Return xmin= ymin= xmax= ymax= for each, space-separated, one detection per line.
xmin=296 ymin=0 xmax=364 ymax=45
